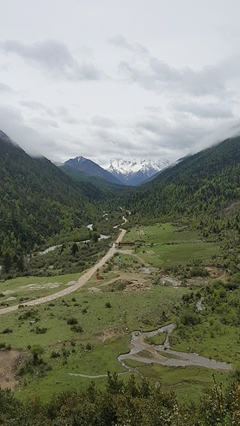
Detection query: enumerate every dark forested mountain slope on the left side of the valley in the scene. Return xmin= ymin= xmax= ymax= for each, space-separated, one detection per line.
xmin=0 ymin=132 xmax=105 ymax=256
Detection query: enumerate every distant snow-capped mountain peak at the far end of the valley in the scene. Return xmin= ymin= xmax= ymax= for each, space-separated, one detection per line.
xmin=103 ymin=158 xmax=170 ymax=185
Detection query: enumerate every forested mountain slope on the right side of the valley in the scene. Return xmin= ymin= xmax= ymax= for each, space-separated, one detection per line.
xmin=126 ymin=137 xmax=240 ymax=233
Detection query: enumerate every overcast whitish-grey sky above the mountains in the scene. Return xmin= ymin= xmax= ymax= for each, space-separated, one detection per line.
xmin=0 ymin=0 xmax=240 ymax=165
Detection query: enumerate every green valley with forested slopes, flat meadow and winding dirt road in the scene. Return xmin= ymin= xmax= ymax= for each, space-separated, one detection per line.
xmin=0 ymin=132 xmax=240 ymax=424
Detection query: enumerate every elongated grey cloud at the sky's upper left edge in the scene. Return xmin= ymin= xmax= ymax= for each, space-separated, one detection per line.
xmin=0 ymin=40 xmax=102 ymax=81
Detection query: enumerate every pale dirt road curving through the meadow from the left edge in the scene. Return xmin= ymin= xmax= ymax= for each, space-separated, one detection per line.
xmin=0 ymin=229 xmax=126 ymax=315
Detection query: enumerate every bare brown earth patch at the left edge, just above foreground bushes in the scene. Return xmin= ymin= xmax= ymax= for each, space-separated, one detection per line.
xmin=0 ymin=351 xmax=22 ymax=390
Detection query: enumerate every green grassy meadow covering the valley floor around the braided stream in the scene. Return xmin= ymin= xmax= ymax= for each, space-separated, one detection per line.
xmin=0 ymin=224 xmax=236 ymax=402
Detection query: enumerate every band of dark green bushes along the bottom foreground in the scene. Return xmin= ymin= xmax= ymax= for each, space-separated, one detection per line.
xmin=0 ymin=373 xmax=240 ymax=426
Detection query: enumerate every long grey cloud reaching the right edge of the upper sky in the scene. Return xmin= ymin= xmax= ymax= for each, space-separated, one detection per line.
xmin=114 ymin=36 xmax=240 ymax=98
